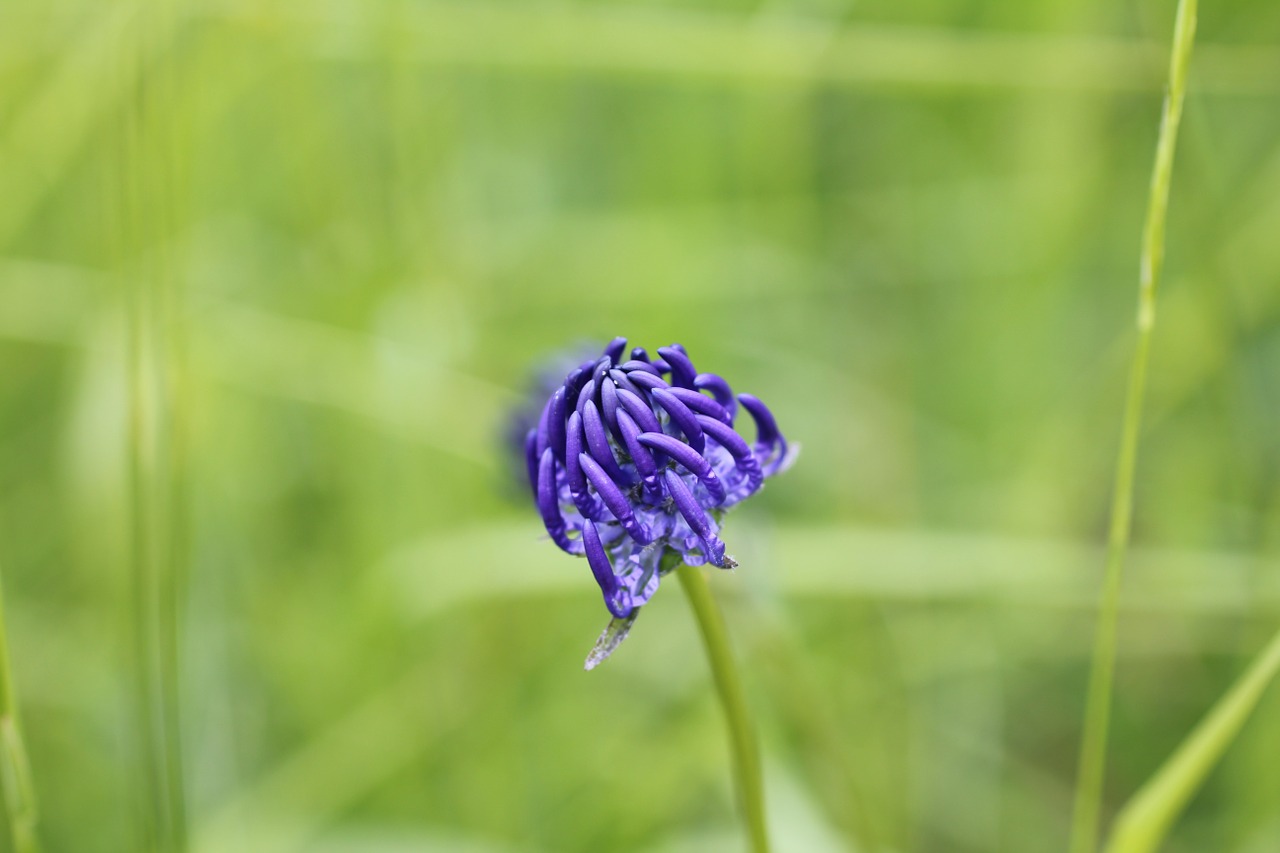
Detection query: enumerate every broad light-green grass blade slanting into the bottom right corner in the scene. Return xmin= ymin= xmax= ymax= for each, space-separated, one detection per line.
xmin=1106 ymin=631 xmax=1280 ymax=853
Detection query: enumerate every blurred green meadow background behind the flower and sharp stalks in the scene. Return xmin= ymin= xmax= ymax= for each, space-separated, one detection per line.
xmin=0 ymin=0 xmax=1280 ymax=853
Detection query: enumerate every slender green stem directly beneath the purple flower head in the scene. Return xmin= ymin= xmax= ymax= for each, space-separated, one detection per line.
xmin=676 ymin=565 xmax=769 ymax=853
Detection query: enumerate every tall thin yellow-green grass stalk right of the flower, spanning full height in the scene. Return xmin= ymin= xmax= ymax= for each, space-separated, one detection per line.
xmin=1070 ymin=0 xmax=1196 ymax=853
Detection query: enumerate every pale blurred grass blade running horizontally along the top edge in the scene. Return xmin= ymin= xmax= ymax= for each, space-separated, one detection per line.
xmin=206 ymin=1 xmax=1280 ymax=93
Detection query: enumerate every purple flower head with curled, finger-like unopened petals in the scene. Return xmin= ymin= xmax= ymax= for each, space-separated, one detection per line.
xmin=525 ymin=338 xmax=795 ymax=635
